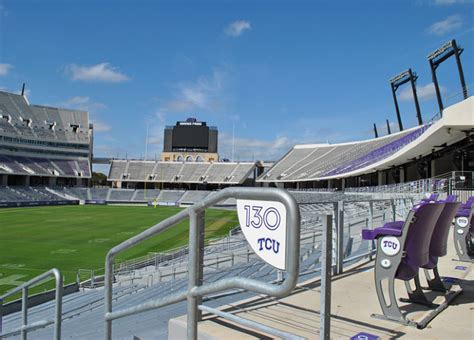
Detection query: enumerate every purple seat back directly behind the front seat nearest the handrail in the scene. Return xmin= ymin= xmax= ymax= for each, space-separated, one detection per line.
xmin=430 ymin=202 xmax=461 ymax=258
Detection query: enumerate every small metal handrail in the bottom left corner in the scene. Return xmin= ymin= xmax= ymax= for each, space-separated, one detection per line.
xmin=0 ymin=268 xmax=63 ymax=340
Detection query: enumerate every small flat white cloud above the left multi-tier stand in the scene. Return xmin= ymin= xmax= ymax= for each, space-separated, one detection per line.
xmin=65 ymin=63 xmax=130 ymax=83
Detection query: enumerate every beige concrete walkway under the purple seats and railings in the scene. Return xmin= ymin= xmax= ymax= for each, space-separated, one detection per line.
xmin=169 ymin=230 xmax=474 ymax=340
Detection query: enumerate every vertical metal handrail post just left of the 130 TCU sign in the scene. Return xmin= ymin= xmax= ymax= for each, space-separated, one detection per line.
xmin=187 ymin=210 xmax=204 ymax=340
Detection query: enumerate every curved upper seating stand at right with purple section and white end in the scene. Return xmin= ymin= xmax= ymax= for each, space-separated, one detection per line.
xmin=257 ymin=97 xmax=474 ymax=182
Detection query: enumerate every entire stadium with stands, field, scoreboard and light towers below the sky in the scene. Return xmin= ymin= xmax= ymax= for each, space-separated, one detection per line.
xmin=0 ymin=12 xmax=474 ymax=339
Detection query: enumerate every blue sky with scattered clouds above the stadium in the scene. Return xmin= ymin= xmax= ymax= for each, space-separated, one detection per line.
xmin=0 ymin=0 xmax=474 ymax=170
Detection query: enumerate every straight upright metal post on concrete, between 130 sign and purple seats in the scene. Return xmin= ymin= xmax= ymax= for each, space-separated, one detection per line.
xmin=319 ymin=215 xmax=332 ymax=340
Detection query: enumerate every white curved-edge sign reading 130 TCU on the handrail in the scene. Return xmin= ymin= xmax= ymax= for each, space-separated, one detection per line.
xmin=237 ymin=200 xmax=286 ymax=270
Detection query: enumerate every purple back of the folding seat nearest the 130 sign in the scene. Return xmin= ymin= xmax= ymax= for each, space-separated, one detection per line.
xmin=402 ymin=202 xmax=445 ymax=268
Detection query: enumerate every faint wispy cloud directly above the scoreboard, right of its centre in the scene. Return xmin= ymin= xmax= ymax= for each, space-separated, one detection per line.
xmin=164 ymin=70 xmax=225 ymax=112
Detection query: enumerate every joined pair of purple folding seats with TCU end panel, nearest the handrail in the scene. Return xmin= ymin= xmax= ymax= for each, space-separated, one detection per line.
xmin=362 ymin=202 xmax=460 ymax=328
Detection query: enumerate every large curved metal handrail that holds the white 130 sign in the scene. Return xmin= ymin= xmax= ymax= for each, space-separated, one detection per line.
xmin=104 ymin=188 xmax=300 ymax=340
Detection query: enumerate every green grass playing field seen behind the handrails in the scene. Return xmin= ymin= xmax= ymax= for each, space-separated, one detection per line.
xmin=0 ymin=205 xmax=238 ymax=294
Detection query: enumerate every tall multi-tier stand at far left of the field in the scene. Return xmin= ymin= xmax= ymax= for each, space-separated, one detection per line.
xmin=0 ymin=91 xmax=93 ymax=186
